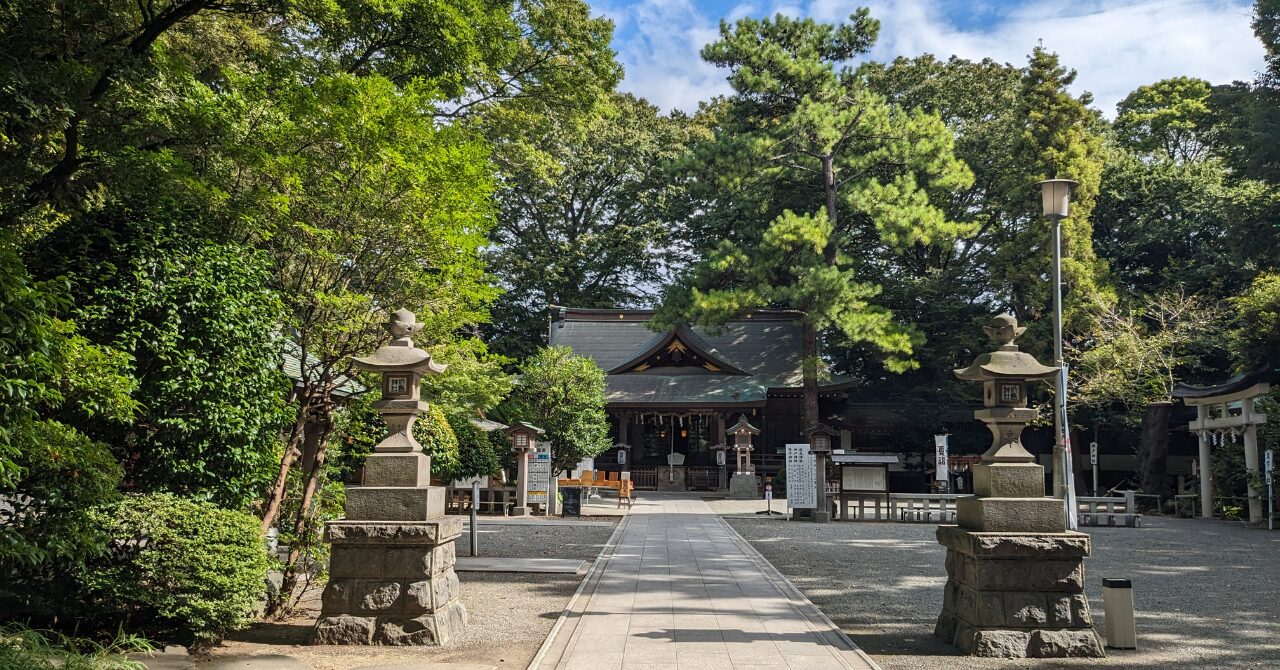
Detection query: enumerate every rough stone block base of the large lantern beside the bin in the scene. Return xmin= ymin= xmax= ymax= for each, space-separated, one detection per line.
xmin=933 ymin=525 xmax=1105 ymax=658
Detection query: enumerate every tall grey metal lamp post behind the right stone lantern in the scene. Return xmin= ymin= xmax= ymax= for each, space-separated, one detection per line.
xmin=1039 ymin=179 xmax=1076 ymax=530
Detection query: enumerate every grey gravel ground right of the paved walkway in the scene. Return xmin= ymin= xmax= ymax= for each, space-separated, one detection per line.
xmin=730 ymin=518 xmax=1280 ymax=670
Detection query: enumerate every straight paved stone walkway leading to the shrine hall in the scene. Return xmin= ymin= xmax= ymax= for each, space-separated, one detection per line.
xmin=539 ymin=494 xmax=876 ymax=670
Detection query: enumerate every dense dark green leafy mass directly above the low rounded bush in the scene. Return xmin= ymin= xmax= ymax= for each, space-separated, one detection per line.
xmin=32 ymin=208 xmax=289 ymax=510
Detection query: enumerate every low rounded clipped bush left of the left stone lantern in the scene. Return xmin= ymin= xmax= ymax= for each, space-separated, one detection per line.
xmin=82 ymin=493 xmax=268 ymax=646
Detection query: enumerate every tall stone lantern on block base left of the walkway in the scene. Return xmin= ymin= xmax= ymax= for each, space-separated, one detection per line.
xmin=311 ymin=310 xmax=467 ymax=646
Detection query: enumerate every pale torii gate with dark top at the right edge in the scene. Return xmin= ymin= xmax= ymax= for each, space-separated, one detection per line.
xmin=1172 ymin=370 xmax=1271 ymax=524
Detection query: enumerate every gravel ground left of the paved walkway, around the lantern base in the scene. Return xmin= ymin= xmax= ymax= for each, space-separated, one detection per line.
xmin=204 ymin=523 xmax=613 ymax=670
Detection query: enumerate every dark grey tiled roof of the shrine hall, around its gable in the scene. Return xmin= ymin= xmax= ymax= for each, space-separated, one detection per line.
xmin=550 ymin=309 xmax=801 ymax=405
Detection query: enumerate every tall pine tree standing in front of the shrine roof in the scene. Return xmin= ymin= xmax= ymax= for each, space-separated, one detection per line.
xmin=655 ymin=10 xmax=972 ymax=423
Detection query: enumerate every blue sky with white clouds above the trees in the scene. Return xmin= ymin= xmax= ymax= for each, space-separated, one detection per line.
xmin=588 ymin=0 xmax=1262 ymax=117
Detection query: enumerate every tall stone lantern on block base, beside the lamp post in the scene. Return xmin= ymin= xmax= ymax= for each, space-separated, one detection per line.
xmin=934 ymin=314 xmax=1103 ymax=658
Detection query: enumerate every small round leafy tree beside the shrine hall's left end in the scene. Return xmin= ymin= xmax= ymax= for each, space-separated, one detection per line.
xmin=507 ymin=347 xmax=611 ymax=471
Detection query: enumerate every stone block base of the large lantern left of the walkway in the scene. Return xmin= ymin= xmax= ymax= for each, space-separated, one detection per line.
xmin=311 ymin=518 xmax=467 ymax=644
